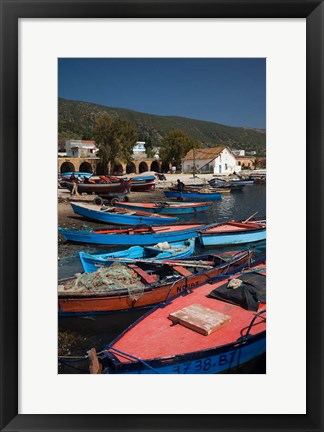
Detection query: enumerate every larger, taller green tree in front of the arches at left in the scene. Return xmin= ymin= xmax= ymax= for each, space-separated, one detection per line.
xmin=93 ymin=113 xmax=138 ymax=174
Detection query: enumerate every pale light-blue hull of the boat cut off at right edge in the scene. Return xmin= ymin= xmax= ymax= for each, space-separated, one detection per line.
xmin=199 ymin=229 xmax=266 ymax=246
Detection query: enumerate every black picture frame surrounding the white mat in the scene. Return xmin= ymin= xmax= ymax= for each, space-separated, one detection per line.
xmin=0 ymin=0 xmax=324 ymax=431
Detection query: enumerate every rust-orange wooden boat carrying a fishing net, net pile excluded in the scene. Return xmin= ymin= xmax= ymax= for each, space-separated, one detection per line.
xmin=58 ymin=250 xmax=252 ymax=315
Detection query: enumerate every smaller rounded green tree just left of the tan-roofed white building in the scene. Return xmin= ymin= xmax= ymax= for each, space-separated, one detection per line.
xmin=160 ymin=129 xmax=201 ymax=167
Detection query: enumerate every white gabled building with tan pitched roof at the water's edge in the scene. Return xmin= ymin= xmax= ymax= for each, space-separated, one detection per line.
xmin=182 ymin=147 xmax=241 ymax=174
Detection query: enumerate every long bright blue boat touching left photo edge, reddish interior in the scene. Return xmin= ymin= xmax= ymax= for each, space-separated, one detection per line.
xmin=58 ymin=224 xmax=204 ymax=246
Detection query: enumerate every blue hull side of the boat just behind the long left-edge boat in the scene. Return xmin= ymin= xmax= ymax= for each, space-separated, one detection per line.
xmin=71 ymin=204 xmax=177 ymax=226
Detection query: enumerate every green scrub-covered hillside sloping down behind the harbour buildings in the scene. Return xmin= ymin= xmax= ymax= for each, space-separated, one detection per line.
xmin=58 ymin=98 xmax=266 ymax=156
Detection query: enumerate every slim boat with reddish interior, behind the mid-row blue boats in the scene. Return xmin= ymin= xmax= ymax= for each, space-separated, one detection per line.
xmin=116 ymin=201 xmax=213 ymax=215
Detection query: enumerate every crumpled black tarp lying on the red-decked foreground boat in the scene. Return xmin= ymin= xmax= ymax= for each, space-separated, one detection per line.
xmin=208 ymin=273 xmax=266 ymax=312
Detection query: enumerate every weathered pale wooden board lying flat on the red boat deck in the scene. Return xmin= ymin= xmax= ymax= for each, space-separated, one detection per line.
xmin=168 ymin=304 xmax=231 ymax=336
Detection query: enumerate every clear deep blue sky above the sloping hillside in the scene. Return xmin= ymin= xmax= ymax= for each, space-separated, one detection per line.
xmin=58 ymin=58 xmax=266 ymax=128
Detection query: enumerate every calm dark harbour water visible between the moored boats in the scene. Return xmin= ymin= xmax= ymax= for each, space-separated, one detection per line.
xmin=58 ymin=185 xmax=266 ymax=373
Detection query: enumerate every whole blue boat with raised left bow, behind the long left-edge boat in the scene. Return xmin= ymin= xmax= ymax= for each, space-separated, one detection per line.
xmin=71 ymin=204 xmax=178 ymax=226
